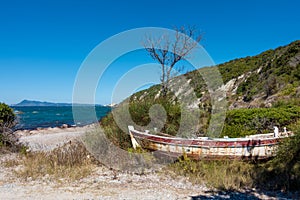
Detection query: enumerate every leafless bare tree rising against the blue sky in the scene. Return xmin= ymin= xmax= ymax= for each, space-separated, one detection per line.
xmin=144 ymin=26 xmax=202 ymax=96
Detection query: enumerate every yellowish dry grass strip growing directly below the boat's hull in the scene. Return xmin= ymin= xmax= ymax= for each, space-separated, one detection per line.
xmin=169 ymin=159 xmax=254 ymax=190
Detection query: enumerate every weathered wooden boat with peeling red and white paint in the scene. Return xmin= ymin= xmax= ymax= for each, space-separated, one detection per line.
xmin=128 ymin=126 xmax=293 ymax=160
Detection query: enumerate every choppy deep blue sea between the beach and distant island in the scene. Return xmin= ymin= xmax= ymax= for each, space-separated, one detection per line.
xmin=12 ymin=106 xmax=111 ymax=130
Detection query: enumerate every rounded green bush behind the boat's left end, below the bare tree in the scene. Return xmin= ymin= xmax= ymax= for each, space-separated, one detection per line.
xmin=101 ymin=97 xmax=181 ymax=143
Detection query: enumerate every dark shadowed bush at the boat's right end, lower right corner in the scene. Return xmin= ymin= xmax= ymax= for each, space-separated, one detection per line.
xmin=255 ymin=120 xmax=300 ymax=191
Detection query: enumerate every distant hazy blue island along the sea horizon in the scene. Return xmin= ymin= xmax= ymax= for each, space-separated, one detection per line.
xmin=12 ymin=99 xmax=109 ymax=107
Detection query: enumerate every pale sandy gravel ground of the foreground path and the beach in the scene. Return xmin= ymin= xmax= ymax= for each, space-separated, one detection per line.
xmin=0 ymin=127 xmax=296 ymax=200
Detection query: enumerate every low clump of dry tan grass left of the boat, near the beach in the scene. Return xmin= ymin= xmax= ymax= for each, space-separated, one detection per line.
xmin=7 ymin=142 xmax=95 ymax=181
